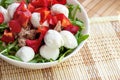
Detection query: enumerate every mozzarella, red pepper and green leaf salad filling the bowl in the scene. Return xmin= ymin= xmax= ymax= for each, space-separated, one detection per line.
xmin=0 ymin=0 xmax=89 ymax=63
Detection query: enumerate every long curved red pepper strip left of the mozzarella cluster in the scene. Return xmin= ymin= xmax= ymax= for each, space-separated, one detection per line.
xmin=26 ymin=27 xmax=48 ymax=53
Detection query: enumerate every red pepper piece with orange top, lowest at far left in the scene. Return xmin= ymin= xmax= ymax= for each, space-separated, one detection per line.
xmin=1 ymin=30 xmax=14 ymax=43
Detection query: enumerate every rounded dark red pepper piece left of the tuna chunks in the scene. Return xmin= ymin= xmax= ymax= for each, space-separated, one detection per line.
xmin=9 ymin=20 xmax=21 ymax=33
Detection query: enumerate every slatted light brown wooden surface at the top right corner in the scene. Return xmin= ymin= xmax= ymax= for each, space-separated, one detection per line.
xmin=79 ymin=0 xmax=120 ymax=18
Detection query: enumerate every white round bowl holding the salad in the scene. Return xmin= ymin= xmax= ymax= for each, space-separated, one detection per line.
xmin=0 ymin=0 xmax=89 ymax=69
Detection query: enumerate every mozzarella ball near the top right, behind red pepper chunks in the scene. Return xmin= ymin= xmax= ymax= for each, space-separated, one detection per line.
xmin=51 ymin=4 xmax=69 ymax=17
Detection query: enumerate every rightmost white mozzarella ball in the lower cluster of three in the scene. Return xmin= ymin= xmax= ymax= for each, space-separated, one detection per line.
xmin=60 ymin=30 xmax=78 ymax=49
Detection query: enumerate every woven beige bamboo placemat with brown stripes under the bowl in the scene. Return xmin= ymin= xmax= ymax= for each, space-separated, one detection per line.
xmin=0 ymin=17 xmax=120 ymax=80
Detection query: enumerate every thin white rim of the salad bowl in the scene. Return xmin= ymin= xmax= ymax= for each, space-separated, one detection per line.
xmin=0 ymin=0 xmax=90 ymax=66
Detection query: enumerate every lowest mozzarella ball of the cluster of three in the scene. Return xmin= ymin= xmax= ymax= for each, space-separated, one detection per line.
xmin=40 ymin=45 xmax=59 ymax=60
